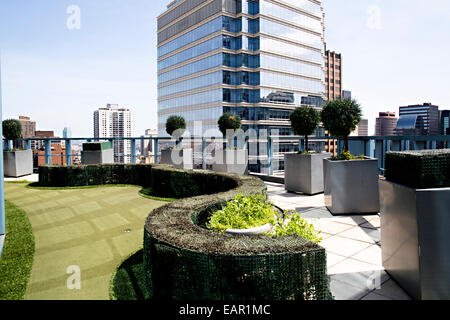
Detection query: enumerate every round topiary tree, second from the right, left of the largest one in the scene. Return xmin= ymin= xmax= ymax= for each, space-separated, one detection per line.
xmin=290 ymin=106 xmax=320 ymax=152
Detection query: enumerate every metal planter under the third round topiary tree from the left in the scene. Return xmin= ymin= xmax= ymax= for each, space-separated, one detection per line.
xmin=212 ymin=150 xmax=248 ymax=174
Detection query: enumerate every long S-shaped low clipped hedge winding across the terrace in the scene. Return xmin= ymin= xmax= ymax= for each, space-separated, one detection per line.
xmin=39 ymin=164 xmax=331 ymax=300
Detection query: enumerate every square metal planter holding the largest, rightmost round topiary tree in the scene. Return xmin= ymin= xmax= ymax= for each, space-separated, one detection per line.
xmin=323 ymin=158 xmax=380 ymax=215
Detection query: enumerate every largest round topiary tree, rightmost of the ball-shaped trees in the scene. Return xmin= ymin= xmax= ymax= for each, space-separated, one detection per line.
xmin=321 ymin=99 xmax=362 ymax=152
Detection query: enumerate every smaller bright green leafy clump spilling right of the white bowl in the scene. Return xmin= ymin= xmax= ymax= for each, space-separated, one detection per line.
xmin=270 ymin=211 xmax=323 ymax=243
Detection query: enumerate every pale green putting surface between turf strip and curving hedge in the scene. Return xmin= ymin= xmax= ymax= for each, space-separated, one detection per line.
xmin=5 ymin=183 xmax=166 ymax=300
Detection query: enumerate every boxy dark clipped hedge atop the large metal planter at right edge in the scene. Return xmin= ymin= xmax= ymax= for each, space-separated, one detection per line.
xmin=385 ymin=149 xmax=450 ymax=189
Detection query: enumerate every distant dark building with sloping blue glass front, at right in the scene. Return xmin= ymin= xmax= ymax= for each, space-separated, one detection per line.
xmin=395 ymin=103 xmax=441 ymax=135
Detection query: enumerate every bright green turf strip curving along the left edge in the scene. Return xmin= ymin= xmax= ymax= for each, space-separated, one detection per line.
xmin=0 ymin=201 xmax=34 ymax=300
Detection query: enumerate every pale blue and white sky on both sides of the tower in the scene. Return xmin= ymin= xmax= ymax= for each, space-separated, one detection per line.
xmin=0 ymin=0 xmax=450 ymax=137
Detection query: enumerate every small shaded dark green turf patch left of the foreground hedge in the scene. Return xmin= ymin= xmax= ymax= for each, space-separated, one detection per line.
xmin=110 ymin=249 xmax=150 ymax=300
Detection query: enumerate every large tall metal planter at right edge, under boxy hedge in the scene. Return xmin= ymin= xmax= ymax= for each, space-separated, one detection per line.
xmin=380 ymin=180 xmax=450 ymax=300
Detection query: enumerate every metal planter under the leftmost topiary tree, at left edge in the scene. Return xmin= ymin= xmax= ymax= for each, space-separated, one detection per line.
xmin=3 ymin=150 xmax=33 ymax=178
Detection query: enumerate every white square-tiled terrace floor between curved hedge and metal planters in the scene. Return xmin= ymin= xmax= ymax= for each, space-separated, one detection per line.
xmin=266 ymin=182 xmax=411 ymax=300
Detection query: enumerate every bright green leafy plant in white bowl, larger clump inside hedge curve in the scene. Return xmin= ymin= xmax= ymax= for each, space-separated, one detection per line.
xmin=207 ymin=192 xmax=277 ymax=233
